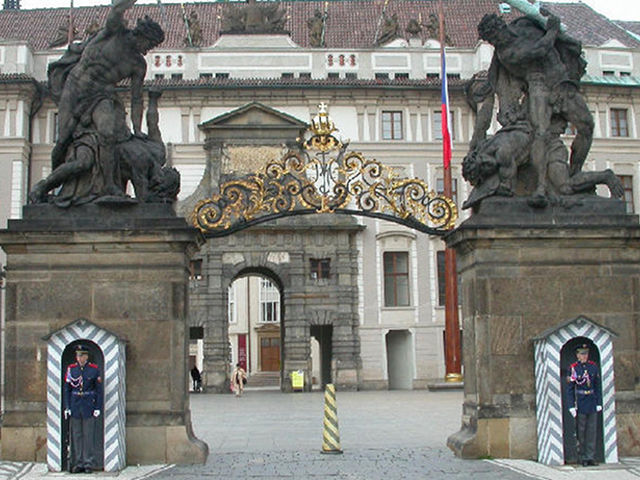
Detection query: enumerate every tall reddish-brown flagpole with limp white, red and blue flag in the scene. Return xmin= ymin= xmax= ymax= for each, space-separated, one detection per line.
xmin=438 ymin=0 xmax=462 ymax=382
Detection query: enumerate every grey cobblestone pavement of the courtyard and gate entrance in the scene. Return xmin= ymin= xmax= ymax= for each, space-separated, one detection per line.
xmin=0 ymin=390 xmax=640 ymax=480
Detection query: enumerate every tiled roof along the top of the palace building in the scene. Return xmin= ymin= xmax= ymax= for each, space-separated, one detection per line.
xmin=0 ymin=0 xmax=640 ymax=50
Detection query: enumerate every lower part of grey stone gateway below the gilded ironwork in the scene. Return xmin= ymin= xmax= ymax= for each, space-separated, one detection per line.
xmin=191 ymin=216 xmax=362 ymax=392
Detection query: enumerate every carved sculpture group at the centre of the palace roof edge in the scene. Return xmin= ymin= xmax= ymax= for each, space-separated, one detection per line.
xmin=222 ymin=0 xmax=287 ymax=34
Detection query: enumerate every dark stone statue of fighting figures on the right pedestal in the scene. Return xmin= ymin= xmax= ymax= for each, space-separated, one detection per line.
xmin=463 ymin=9 xmax=624 ymax=208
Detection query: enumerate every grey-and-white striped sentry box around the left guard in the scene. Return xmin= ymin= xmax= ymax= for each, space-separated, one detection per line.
xmin=45 ymin=319 xmax=126 ymax=472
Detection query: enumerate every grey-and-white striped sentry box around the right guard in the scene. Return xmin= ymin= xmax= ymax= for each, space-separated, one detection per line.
xmin=533 ymin=317 xmax=618 ymax=465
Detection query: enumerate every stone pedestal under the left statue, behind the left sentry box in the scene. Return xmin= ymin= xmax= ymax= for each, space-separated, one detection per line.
xmin=0 ymin=204 xmax=208 ymax=464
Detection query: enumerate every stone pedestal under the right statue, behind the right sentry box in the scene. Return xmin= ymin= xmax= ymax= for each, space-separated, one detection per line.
xmin=446 ymin=198 xmax=640 ymax=459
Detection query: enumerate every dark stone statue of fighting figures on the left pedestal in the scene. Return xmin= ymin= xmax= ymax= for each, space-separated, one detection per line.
xmin=29 ymin=0 xmax=180 ymax=207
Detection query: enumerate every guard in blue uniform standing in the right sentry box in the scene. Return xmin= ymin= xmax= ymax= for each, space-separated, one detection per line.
xmin=566 ymin=345 xmax=602 ymax=467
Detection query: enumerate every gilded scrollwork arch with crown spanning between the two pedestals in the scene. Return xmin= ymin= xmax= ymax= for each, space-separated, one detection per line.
xmin=191 ymin=104 xmax=458 ymax=236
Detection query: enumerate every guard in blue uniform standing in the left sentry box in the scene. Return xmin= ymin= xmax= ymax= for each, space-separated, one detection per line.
xmin=64 ymin=345 xmax=102 ymax=473
